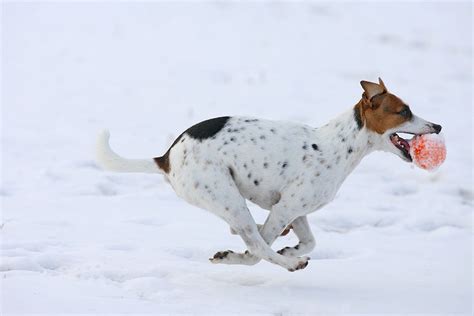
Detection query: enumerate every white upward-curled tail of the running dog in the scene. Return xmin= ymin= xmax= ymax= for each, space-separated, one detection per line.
xmin=96 ymin=130 xmax=163 ymax=173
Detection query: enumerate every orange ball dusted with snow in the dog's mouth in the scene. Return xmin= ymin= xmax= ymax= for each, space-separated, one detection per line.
xmin=410 ymin=134 xmax=446 ymax=171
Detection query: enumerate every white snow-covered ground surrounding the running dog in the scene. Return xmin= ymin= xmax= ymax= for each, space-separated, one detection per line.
xmin=0 ymin=2 xmax=473 ymax=315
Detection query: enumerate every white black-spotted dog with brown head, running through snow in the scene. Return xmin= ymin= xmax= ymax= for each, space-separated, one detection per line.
xmin=97 ymin=78 xmax=441 ymax=271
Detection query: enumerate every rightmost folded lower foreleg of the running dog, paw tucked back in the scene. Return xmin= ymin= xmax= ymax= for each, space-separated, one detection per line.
xmin=278 ymin=216 xmax=316 ymax=257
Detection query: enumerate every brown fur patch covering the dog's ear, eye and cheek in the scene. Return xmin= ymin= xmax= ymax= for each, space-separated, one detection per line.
xmin=357 ymin=78 xmax=412 ymax=134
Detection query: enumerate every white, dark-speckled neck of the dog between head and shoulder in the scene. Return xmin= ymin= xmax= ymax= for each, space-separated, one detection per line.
xmin=317 ymin=100 xmax=380 ymax=181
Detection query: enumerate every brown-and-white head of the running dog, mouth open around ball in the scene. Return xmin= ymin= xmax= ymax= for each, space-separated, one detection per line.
xmin=357 ymin=78 xmax=441 ymax=162
